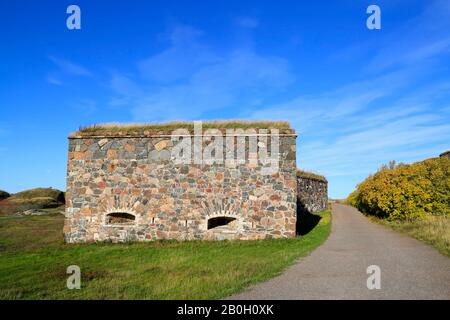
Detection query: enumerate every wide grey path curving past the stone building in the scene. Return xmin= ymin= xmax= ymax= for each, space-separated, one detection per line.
xmin=229 ymin=204 xmax=450 ymax=299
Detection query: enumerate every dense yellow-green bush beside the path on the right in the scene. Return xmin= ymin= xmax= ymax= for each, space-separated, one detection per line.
xmin=347 ymin=158 xmax=450 ymax=220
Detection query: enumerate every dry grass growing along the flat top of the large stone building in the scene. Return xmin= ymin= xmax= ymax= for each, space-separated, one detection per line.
xmin=74 ymin=120 xmax=290 ymax=136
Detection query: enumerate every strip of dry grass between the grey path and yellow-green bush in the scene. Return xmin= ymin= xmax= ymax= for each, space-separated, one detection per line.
xmin=369 ymin=216 xmax=450 ymax=257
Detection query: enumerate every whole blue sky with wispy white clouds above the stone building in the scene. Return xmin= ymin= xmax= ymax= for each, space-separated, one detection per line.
xmin=0 ymin=0 xmax=450 ymax=198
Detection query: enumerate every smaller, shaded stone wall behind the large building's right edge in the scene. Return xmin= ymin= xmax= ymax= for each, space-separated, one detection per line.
xmin=297 ymin=175 xmax=328 ymax=214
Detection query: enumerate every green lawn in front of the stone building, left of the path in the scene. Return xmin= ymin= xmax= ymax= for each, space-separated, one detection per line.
xmin=0 ymin=211 xmax=331 ymax=299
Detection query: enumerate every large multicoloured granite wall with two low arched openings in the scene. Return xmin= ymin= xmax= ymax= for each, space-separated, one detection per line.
xmin=64 ymin=129 xmax=299 ymax=243
